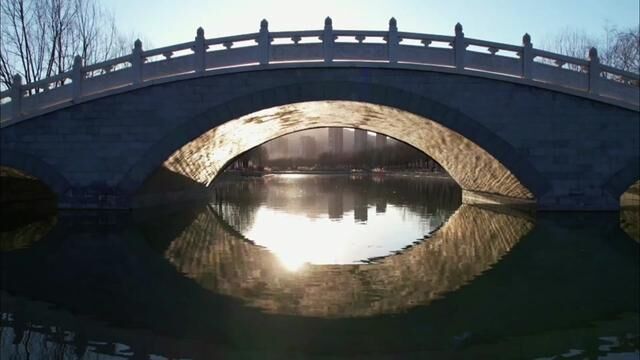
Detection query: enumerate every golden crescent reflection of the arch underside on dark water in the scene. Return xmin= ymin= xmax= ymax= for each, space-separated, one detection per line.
xmin=165 ymin=205 xmax=533 ymax=317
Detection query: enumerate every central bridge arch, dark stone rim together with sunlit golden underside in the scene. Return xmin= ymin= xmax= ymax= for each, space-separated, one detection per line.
xmin=118 ymin=81 xmax=549 ymax=205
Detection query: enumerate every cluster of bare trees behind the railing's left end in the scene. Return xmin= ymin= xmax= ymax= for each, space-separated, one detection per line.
xmin=0 ymin=0 xmax=132 ymax=88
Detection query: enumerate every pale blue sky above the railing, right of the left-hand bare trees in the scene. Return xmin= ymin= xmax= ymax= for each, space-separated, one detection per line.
xmin=102 ymin=0 xmax=640 ymax=48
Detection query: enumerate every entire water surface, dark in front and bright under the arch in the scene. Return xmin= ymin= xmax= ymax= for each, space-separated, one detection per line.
xmin=0 ymin=174 xmax=640 ymax=359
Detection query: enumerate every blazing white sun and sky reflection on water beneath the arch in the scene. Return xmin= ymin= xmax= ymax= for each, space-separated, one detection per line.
xmin=244 ymin=205 xmax=433 ymax=271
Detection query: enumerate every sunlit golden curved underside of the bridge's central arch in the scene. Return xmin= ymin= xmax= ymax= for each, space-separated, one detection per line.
xmin=163 ymin=101 xmax=534 ymax=200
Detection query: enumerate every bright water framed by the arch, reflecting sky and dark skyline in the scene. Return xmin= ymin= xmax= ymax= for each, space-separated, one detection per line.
xmin=213 ymin=175 xmax=460 ymax=270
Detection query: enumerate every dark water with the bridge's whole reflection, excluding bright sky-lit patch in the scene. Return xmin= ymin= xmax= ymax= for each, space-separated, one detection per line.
xmin=0 ymin=184 xmax=640 ymax=359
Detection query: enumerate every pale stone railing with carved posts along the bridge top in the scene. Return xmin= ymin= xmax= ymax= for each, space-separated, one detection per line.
xmin=0 ymin=18 xmax=640 ymax=126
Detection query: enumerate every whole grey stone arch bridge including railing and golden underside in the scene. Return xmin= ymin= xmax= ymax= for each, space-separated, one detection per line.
xmin=0 ymin=18 xmax=640 ymax=210
